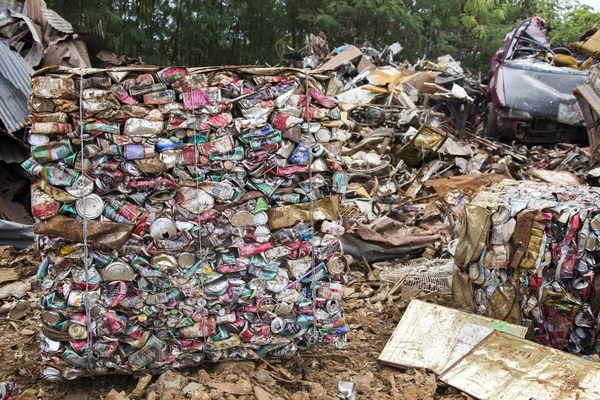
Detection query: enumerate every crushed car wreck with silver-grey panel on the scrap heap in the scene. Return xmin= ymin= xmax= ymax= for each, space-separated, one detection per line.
xmin=486 ymin=17 xmax=588 ymax=143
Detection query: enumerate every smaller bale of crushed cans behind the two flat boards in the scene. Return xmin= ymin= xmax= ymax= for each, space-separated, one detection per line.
xmin=453 ymin=180 xmax=600 ymax=355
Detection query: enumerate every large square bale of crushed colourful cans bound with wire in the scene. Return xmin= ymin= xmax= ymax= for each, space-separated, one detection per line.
xmin=23 ymin=66 xmax=349 ymax=379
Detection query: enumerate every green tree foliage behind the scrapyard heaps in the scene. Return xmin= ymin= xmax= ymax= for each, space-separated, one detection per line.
xmin=47 ymin=0 xmax=600 ymax=73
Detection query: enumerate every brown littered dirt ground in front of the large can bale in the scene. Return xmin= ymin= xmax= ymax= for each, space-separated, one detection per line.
xmin=0 ymin=247 xmax=467 ymax=400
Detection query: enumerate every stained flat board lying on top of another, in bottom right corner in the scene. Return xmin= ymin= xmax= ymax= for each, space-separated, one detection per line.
xmin=440 ymin=331 xmax=600 ymax=400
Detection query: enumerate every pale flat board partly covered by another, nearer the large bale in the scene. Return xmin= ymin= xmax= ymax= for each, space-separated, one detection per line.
xmin=379 ymin=300 xmax=527 ymax=374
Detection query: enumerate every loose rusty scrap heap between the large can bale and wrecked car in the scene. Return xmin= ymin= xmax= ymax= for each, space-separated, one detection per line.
xmin=288 ymin=41 xmax=597 ymax=262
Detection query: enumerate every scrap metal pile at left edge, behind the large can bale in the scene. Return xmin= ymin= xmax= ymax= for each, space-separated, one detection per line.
xmin=0 ymin=0 xmax=123 ymax=244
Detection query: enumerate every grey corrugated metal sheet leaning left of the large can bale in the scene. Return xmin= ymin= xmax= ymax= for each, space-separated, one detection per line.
xmin=0 ymin=43 xmax=33 ymax=133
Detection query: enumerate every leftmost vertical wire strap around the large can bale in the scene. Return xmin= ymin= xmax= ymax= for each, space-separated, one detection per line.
xmin=79 ymin=72 xmax=94 ymax=375
